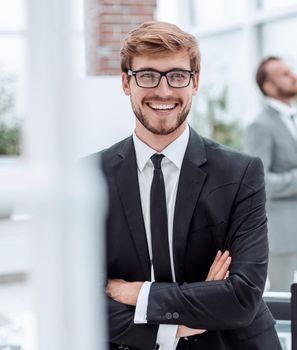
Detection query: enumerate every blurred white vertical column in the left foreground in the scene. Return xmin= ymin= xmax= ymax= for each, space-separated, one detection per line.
xmin=23 ymin=0 xmax=105 ymax=350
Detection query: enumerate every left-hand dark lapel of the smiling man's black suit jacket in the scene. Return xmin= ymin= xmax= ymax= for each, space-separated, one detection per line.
xmin=116 ymin=137 xmax=151 ymax=280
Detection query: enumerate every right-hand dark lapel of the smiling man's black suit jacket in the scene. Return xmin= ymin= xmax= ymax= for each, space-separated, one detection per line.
xmin=173 ymin=128 xmax=207 ymax=281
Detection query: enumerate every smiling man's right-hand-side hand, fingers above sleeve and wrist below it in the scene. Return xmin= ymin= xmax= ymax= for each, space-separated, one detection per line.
xmin=176 ymin=250 xmax=231 ymax=338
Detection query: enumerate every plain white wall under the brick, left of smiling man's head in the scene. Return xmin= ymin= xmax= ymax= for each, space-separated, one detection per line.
xmin=75 ymin=76 xmax=134 ymax=156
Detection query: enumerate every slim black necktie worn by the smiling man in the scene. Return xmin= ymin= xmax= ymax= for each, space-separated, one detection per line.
xmin=150 ymin=154 xmax=172 ymax=282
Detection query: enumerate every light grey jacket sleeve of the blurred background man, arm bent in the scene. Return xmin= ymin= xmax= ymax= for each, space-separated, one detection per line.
xmin=245 ymin=123 xmax=297 ymax=198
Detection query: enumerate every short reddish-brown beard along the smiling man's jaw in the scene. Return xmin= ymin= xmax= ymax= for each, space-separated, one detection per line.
xmin=131 ymin=99 xmax=191 ymax=135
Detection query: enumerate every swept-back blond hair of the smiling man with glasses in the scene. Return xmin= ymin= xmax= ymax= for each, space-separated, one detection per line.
xmin=120 ymin=21 xmax=200 ymax=73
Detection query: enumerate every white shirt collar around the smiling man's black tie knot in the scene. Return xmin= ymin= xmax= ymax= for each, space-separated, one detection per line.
xmin=133 ymin=124 xmax=190 ymax=171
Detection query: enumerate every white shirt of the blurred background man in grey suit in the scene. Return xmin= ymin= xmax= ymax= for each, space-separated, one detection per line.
xmin=266 ymin=97 xmax=297 ymax=140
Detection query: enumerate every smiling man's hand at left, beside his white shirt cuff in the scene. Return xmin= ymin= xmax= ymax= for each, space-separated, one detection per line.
xmin=105 ymin=279 xmax=143 ymax=306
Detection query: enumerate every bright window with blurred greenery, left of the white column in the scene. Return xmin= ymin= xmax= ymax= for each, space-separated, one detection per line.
xmin=0 ymin=0 xmax=26 ymax=155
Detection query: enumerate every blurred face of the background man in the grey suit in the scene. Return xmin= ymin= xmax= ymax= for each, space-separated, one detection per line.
xmin=264 ymin=60 xmax=297 ymax=100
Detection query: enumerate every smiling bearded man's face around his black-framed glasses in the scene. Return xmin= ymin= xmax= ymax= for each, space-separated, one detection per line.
xmin=122 ymin=52 xmax=198 ymax=135
